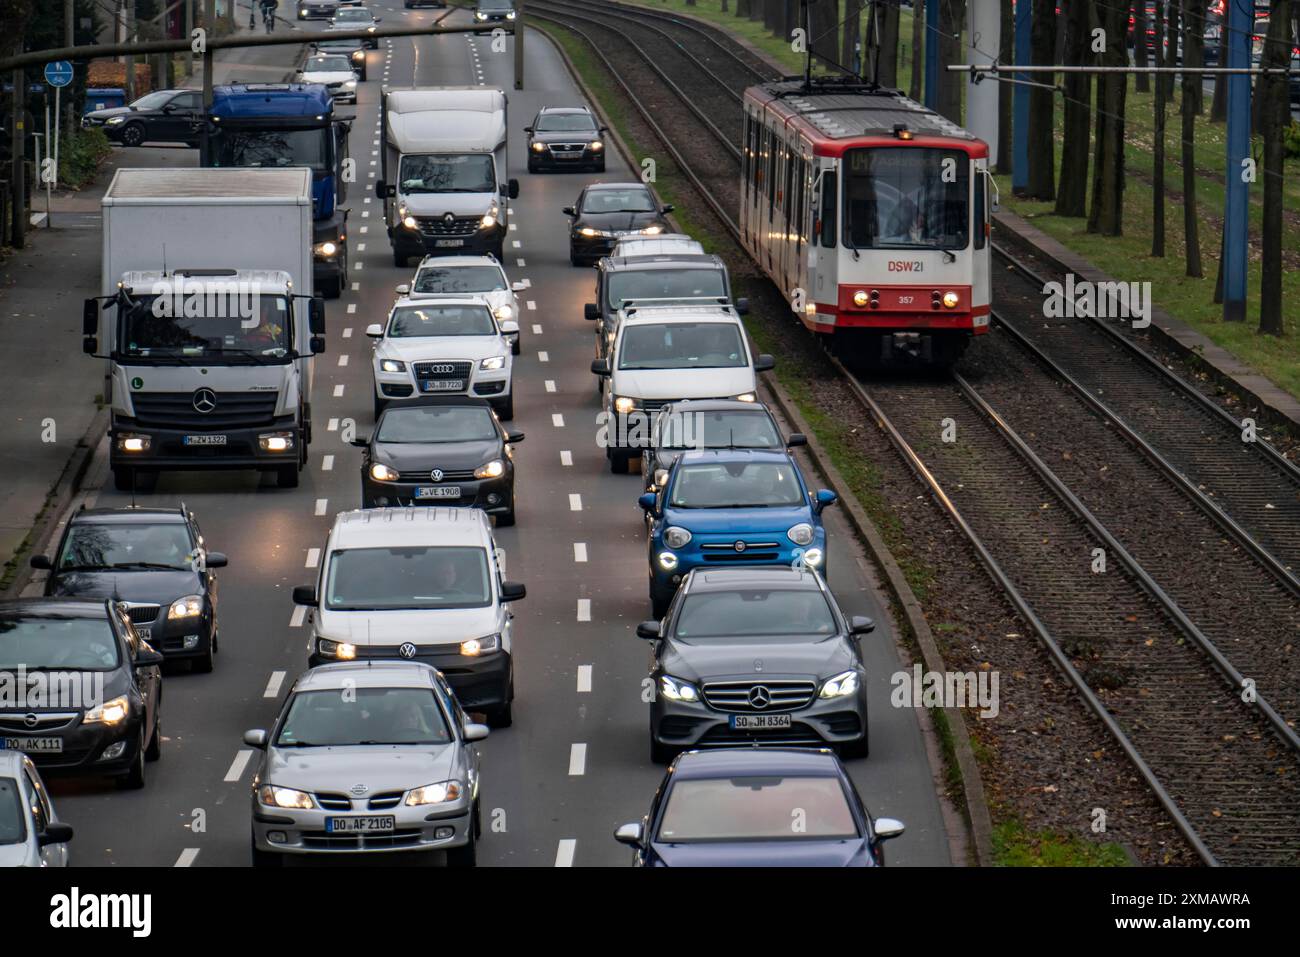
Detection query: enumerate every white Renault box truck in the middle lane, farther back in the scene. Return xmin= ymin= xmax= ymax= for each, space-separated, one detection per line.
xmin=374 ymin=86 xmax=519 ymax=267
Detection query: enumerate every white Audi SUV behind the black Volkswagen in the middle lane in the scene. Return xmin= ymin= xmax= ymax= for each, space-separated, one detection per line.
xmin=365 ymin=296 xmax=519 ymax=421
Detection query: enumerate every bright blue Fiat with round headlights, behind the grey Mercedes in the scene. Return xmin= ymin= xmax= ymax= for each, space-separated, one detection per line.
xmin=640 ymin=449 xmax=836 ymax=618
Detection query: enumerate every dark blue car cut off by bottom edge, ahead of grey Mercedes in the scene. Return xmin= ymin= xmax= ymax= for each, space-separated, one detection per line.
xmin=614 ymin=749 xmax=904 ymax=867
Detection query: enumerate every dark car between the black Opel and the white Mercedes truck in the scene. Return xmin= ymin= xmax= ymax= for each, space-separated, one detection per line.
xmin=31 ymin=507 xmax=226 ymax=672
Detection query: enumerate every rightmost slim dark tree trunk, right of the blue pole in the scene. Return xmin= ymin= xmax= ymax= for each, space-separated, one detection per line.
xmin=1258 ymin=0 xmax=1292 ymax=335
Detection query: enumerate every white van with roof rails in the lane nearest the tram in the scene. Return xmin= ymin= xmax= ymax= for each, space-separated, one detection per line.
xmin=592 ymin=304 xmax=776 ymax=473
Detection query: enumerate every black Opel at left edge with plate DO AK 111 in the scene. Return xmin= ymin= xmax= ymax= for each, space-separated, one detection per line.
xmin=0 ymin=598 xmax=163 ymax=788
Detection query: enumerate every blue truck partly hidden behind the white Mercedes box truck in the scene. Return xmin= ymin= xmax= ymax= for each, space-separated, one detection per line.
xmin=199 ymin=83 xmax=351 ymax=299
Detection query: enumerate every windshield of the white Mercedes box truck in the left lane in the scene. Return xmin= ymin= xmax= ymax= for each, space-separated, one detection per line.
xmin=120 ymin=291 xmax=293 ymax=363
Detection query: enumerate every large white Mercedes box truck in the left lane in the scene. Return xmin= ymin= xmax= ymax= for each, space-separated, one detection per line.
xmin=82 ymin=168 xmax=325 ymax=492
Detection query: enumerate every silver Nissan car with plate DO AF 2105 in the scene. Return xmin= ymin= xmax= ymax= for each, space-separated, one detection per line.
xmin=244 ymin=661 xmax=488 ymax=867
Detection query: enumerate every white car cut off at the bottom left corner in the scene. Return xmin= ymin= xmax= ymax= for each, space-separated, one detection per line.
xmin=0 ymin=754 xmax=73 ymax=867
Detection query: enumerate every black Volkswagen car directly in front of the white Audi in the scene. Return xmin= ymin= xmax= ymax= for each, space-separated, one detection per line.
xmin=352 ymin=395 xmax=524 ymax=527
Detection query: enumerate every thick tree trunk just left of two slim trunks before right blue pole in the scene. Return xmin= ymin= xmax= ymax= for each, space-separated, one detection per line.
xmin=1088 ymin=4 xmax=1128 ymax=235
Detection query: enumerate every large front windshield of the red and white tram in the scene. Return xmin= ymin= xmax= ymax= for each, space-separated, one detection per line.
xmin=844 ymin=147 xmax=970 ymax=250
